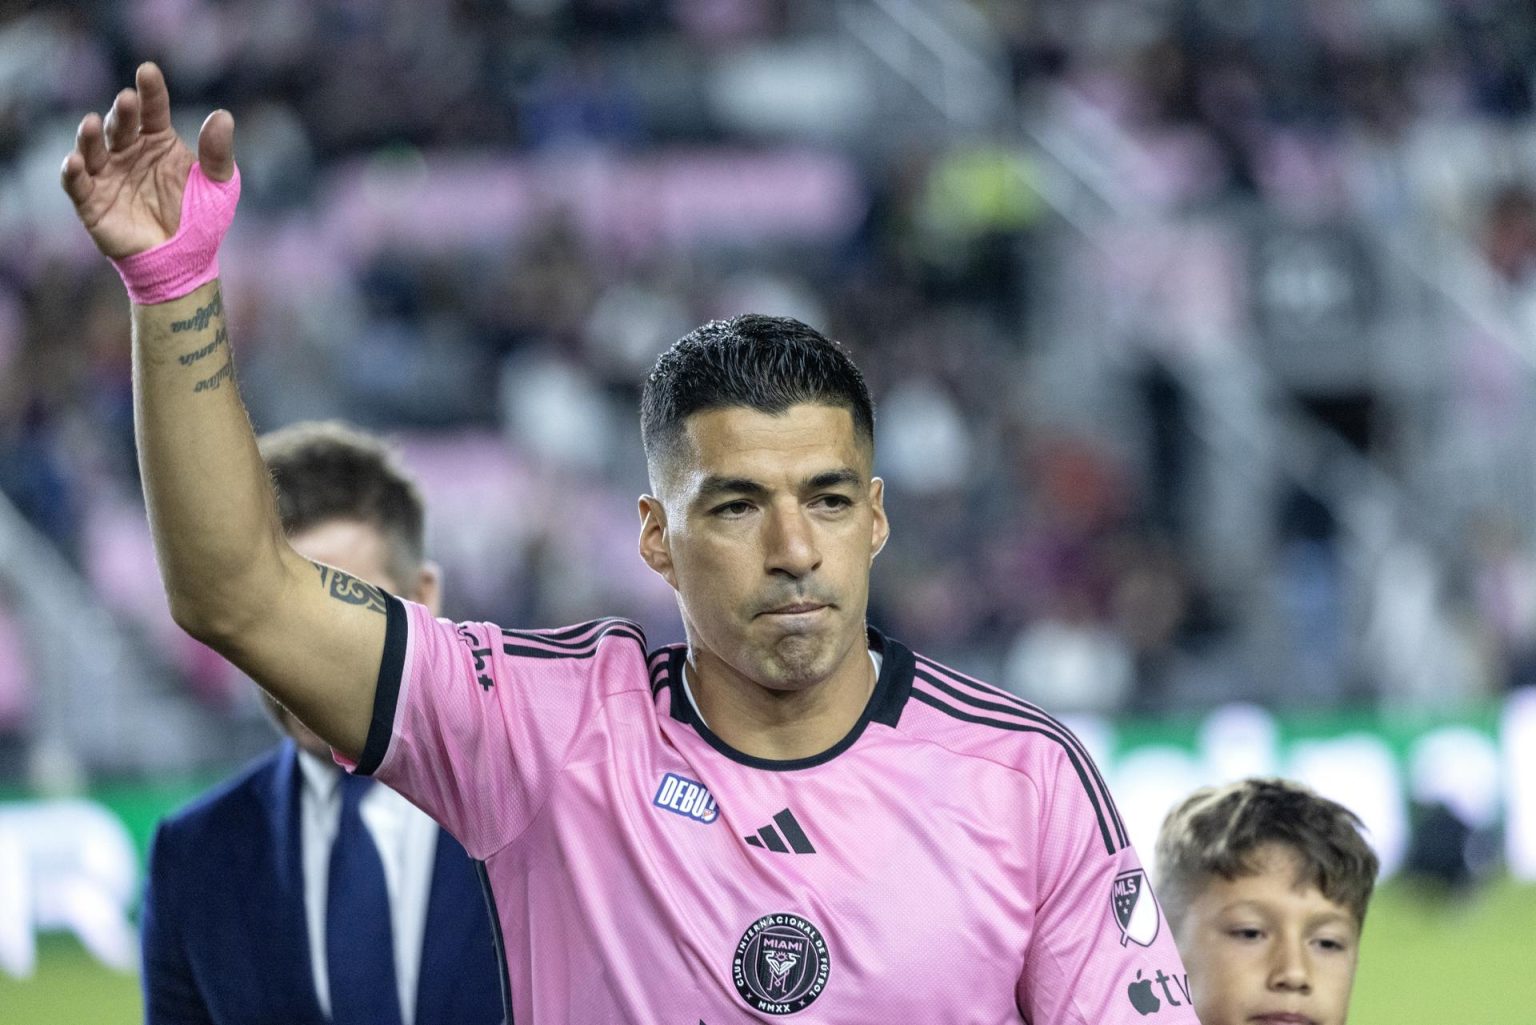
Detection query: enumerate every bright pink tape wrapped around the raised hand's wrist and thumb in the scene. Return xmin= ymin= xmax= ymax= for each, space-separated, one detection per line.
xmin=112 ymin=161 xmax=240 ymax=306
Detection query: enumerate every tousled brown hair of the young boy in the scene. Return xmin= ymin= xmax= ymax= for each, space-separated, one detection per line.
xmin=1157 ymin=779 xmax=1381 ymax=931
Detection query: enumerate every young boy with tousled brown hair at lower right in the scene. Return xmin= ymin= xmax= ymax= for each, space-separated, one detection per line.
xmin=1157 ymin=779 xmax=1378 ymax=1025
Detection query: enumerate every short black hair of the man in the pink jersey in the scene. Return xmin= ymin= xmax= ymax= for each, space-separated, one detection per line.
xmin=641 ymin=313 xmax=874 ymax=473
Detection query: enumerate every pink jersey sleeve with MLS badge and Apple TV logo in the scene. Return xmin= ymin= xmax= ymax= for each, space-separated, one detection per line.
xmin=1017 ymin=745 xmax=1200 ymax=1025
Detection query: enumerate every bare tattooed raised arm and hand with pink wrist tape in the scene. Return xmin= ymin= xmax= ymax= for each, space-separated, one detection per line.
xmin=61 ymin=65 xmax=386 ymax=758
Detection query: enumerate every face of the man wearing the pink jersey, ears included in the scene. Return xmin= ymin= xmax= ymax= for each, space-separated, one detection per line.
xmin=641 ymin=403 xmax=889 ymax=690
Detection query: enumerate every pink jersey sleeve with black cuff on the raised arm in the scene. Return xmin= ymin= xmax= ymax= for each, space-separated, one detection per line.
xmin=335 ymin=596 xmax=645 ymax=859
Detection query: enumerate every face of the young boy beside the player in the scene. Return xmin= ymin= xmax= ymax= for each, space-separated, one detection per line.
xmin=1177 ymin=844 xmax=1359 ymax=1025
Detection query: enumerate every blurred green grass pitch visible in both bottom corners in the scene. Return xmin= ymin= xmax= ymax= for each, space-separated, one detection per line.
xmin=0 ymin=882 xmax=1536 ymax=1025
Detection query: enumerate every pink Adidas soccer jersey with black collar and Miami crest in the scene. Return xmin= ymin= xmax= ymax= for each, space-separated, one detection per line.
xmin=356 ymin=599 xmax=1198 ymax=1025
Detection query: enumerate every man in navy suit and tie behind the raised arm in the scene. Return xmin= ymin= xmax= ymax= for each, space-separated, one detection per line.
xmin=143 ymin=424 xmax=504 ymax=1025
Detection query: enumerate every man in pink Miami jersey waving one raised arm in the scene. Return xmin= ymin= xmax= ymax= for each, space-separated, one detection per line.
xmin=63 ymin=65 xmax=1195 ymax=1025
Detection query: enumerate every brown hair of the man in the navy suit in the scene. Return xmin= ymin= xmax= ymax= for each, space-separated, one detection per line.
xmin=257 ymin=421 xmax=425 ymax=587
